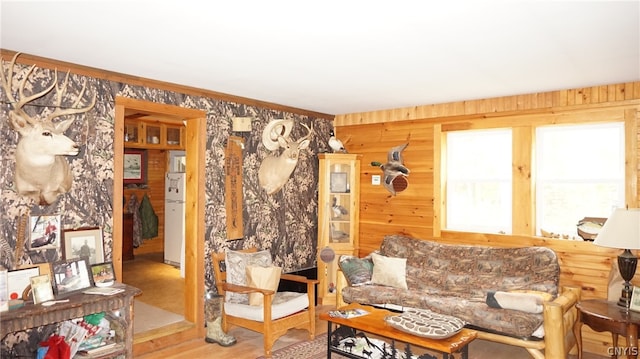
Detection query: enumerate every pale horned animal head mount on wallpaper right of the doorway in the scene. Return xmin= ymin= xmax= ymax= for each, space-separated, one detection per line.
xmin=258 ymin=120 xmax=313 ymax=194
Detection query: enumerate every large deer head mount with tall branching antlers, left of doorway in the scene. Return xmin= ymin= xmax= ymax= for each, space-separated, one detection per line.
xmin=0 ymin=53 xmax=96 ymax=205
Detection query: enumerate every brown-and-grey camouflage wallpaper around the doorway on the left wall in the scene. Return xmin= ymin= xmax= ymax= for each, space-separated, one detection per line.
xmin=0 ymin=60 xmax=333 ymax=357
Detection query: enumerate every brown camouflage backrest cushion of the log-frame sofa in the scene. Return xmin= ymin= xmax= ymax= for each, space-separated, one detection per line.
xmin=380 ymin=235 xmax=560 ymax=302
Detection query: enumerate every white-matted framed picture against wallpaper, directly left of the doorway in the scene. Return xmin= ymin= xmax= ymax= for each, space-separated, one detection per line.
xmin=64 ymin=227 xmax=104 ymax=264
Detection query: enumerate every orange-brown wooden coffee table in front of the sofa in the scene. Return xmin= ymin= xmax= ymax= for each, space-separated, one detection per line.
xmin=319 ymin=304 xmax=478 ymax=359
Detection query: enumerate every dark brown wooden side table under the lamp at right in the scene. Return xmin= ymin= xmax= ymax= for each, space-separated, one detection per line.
xmin=573 ymin=299 xmax=640 ymax=359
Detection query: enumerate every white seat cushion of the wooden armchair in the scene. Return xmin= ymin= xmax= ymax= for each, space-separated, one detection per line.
xmin=224 ymin=292 xmax=309 ymax=322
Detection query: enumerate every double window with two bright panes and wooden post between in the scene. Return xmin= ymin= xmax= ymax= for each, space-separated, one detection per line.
xmin=443 ymin=122 xmax=625 ymax=238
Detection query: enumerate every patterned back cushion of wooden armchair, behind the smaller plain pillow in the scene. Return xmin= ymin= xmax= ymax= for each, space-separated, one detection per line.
xmin=224 ymin=250 xmax=272 ymax=303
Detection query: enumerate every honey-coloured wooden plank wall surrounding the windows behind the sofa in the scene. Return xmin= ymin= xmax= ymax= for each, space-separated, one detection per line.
xmin=335 ymin=82 xmax=640 ymax=355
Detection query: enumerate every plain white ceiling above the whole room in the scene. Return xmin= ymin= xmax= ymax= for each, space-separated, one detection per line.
xmin=0 ymin=0 xmax=640 ymax=114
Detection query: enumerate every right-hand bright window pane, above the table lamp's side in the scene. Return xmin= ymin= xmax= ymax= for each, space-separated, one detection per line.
xmin=536 ymin=122 xmax=625 ymax=237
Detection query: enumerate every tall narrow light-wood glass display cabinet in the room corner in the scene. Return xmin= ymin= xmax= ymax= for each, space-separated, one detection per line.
xmin=318 ymin=153 xmax=362 ymax=305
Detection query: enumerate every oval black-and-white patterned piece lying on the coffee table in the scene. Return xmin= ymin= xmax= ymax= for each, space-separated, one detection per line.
xmin=384 ymin=308 xmax=467 ymax=339
